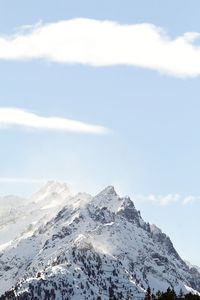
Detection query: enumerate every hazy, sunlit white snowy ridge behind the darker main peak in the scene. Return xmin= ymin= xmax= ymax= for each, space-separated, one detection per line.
xmin=0 ymin=181 xmax=71 ymax=249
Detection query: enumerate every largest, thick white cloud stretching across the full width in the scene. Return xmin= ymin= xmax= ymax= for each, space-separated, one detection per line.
xmin=0 ymin=19 xmax=200 ymax=77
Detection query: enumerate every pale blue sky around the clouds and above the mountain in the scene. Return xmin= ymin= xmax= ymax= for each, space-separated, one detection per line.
xmin=0 ymin=0 xmax=200 ymax=265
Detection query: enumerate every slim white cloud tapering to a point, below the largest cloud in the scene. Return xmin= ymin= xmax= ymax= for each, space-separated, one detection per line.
xmin=0 ymin=108 xmax=109 ymax=134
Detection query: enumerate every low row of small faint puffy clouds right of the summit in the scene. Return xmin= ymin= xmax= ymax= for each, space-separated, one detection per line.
xmin=135 ymin=194 xmax=200 ymax=206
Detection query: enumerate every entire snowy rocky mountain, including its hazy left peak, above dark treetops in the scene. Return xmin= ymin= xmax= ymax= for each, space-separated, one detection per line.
xmin=0 ymin=183 xmax=200 ymax=300
